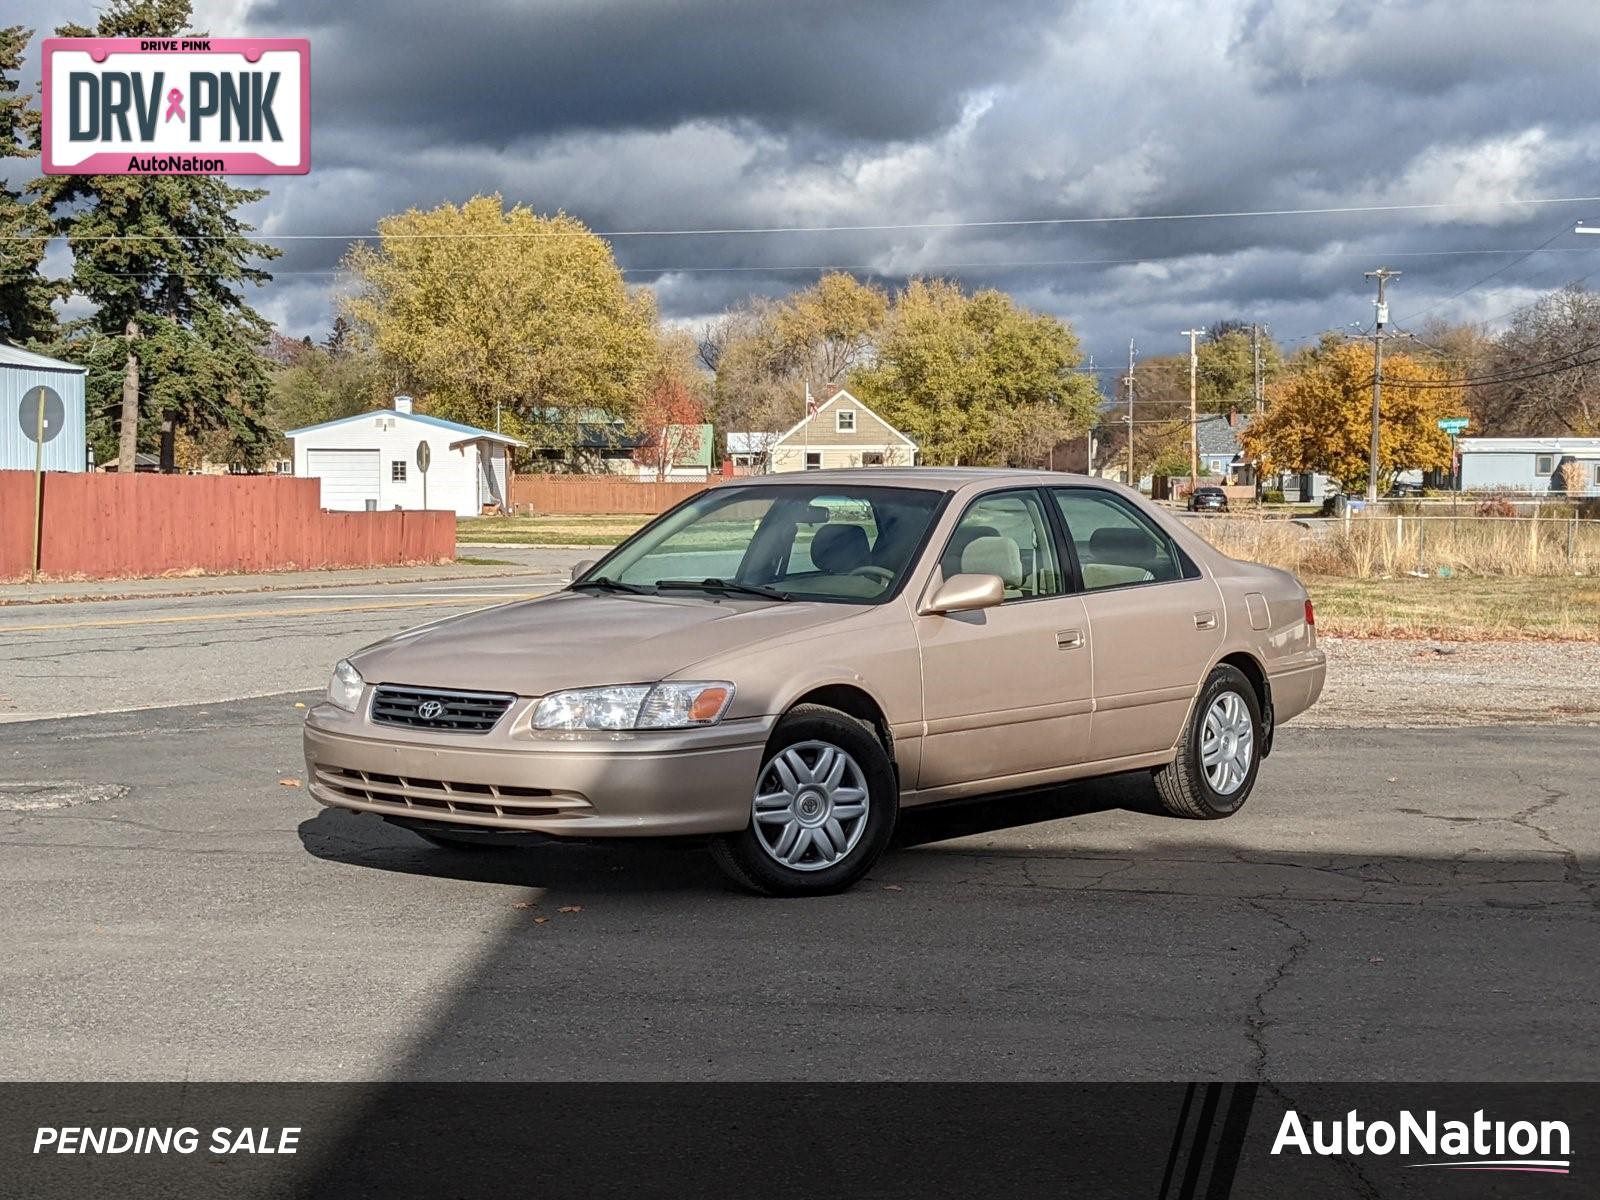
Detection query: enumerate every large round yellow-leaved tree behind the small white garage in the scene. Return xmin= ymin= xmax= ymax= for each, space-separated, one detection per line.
xmin=344 ymin=195 xmax=656 ymax=450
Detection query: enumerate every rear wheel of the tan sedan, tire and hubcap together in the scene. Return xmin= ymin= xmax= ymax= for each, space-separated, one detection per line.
xmin=1155 ymin=664 xmax=1261 ymax=821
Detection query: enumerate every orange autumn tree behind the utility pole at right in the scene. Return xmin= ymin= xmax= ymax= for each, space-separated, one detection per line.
xmin=1240 ymin=342 xmax=1464 ymax=491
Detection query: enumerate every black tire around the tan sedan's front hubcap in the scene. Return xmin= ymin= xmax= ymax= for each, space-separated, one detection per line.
xmin=710 ymin=704 xmax=899 ymax=896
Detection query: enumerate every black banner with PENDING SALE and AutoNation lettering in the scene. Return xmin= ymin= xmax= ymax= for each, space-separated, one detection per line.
xmin=0 ymin=1083 xmax=1600 ymax=1200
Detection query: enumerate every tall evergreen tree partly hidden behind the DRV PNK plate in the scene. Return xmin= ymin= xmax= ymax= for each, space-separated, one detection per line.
xmin=34 ymin=0 xmax=280 ymax=472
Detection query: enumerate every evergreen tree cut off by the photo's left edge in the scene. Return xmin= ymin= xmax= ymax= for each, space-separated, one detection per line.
xmin=0 ymin=26 xmax=56 ymax=342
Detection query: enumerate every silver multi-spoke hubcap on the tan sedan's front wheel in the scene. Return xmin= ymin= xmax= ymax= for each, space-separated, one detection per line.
xmin=752 ymin=742 xmax=870 ymax=870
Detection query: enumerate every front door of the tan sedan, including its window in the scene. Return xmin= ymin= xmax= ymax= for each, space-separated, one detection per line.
xmin=915 ymin=488 xmax=1093 ymax=790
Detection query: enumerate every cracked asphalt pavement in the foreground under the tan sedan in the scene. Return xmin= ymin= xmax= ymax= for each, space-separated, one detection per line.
xmin=0 ymin=691 xmax=1600 ymax=1082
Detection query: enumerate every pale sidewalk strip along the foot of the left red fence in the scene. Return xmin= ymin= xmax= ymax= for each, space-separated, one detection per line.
xmin=0 ymin=546 xmax=574 ymax=606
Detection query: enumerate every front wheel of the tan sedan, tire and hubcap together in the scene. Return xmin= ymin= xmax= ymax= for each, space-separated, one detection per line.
xmin=710 ymin=704 xmax=899 ymax=896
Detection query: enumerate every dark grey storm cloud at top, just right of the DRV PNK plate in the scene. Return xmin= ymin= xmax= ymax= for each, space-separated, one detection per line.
xmin=251 ymin=0 xmax=1062 ymax=146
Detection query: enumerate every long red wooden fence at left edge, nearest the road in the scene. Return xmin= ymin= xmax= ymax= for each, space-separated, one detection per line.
xmin=0 ymin=470 xmax=456 ymax=579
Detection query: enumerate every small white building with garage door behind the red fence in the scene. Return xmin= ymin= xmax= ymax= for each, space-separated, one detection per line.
xmin=285 ymin=397 xmax=523 ymax=517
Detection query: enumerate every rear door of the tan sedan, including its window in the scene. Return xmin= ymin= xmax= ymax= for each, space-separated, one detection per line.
xmin=1051 ymin=486 xmax=1224 ymax=762
